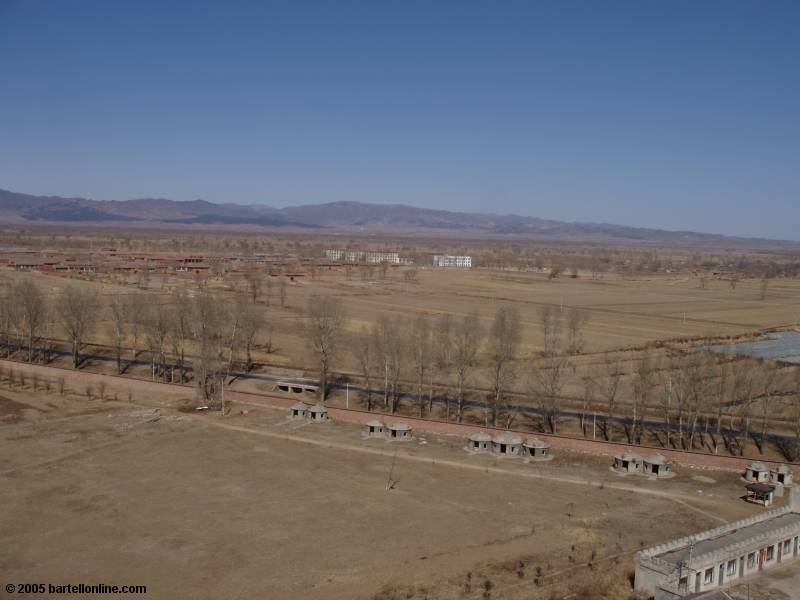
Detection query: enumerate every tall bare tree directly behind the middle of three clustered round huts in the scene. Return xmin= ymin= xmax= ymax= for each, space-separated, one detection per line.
xmin=486 ymin=306 xmax=522 ymax=427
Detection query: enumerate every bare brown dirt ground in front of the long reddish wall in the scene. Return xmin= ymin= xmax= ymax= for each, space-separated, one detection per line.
xmin=0 ymin=389 xmax=780 ymax=600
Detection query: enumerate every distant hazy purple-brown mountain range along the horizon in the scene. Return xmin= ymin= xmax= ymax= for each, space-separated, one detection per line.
xmin=0 ymin=189 xmax=800 ymax=251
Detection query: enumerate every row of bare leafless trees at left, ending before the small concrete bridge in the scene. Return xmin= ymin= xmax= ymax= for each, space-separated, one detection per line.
xmin=0 ymin=279 xmax=271 ymax=408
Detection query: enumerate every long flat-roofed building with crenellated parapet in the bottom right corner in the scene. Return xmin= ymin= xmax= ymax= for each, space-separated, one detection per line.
xmin=634 ymin=490 xmax=800 ymax=600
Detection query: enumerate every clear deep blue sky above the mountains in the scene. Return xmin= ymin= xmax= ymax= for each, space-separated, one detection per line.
xmin=0 ymin=0 xmax=800 ymax=239
